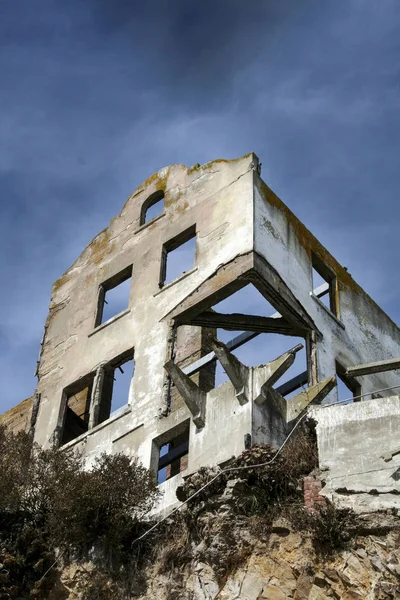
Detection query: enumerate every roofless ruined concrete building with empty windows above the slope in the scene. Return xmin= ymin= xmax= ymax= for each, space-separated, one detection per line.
xmin=2 ymin=154 xmax=400 ymax=509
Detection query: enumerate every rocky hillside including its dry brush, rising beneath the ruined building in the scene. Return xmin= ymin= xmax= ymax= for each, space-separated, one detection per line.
xmin=40 ymin=433 xmax=400 ymax=600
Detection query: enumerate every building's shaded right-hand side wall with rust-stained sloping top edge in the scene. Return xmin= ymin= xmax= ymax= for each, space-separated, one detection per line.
xmin=254 ymin=173 xmax=400 ymax=402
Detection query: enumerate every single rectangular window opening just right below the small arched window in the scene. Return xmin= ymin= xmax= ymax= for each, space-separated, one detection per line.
xmin=159 ymin=225 xmax=196 ymax=288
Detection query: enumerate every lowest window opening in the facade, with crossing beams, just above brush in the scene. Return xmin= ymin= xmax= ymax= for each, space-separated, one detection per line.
xmin=153 ymin=421 xmax=189 ymax=483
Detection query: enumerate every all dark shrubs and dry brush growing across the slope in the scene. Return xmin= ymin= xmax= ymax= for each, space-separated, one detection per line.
xmin=0 ymin=423 xmax=362 ymax=600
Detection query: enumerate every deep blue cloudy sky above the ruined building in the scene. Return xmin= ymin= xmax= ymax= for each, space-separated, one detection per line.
xmin=0 ymin=0 xmax=400 ymax=410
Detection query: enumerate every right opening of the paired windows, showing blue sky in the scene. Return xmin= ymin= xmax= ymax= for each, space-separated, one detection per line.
xmin=98 ymin=351 xmax=135 ymax=423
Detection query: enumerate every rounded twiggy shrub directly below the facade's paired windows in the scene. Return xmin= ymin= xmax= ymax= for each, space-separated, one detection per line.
xmin=49 ymin=454 xmax=158 ymax=561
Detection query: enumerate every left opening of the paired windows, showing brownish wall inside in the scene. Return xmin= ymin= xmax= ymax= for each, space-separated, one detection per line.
xmin=60 ymin=374 xmax=94 ymax=445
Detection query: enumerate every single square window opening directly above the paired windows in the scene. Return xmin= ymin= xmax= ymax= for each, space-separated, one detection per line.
xmin=95 ymin=265 xmax=132 ymax=327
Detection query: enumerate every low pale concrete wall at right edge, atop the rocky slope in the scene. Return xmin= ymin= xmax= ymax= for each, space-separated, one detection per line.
xmin=310 ymin=396 xmax=400 ymax=512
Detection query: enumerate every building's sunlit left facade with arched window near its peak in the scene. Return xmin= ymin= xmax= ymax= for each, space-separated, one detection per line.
xmin=35 ymin=154 xmax=254 ymax=466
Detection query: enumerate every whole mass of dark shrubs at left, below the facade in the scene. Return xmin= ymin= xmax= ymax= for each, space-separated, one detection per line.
xmin=0 ymin=427 xmax=159 ymax=600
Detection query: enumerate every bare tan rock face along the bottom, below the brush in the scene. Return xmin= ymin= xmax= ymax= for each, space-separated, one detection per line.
xmin=54 ymin=512 xmax=400 ymax=600
